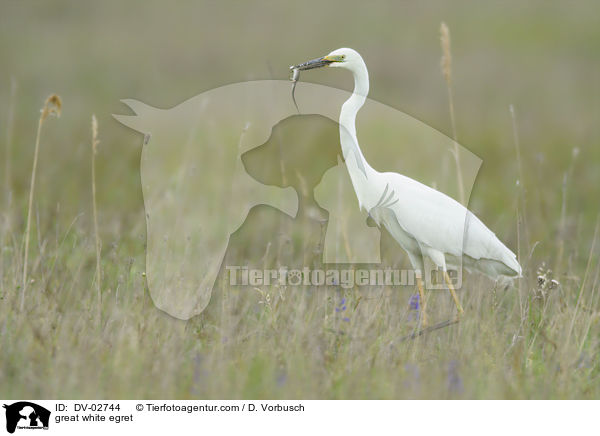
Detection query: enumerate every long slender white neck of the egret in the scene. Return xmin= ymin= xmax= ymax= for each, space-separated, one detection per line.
xmin=340 ymin=62 xmax=375 ymax=210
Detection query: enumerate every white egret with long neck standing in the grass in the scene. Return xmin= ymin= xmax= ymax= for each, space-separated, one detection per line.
xmin=291 ymin=48 xmax=521 ymax=324
